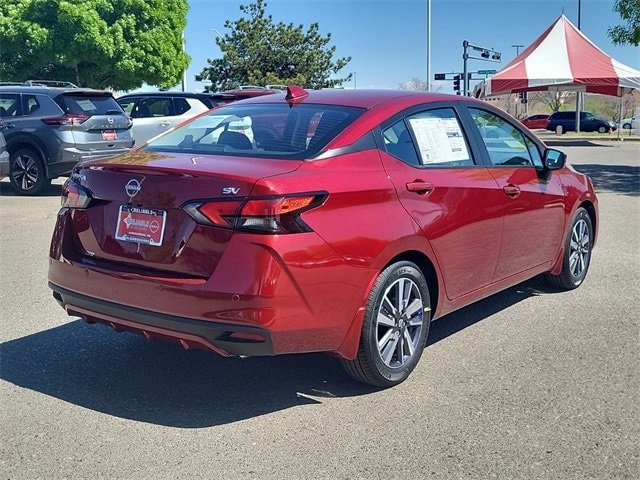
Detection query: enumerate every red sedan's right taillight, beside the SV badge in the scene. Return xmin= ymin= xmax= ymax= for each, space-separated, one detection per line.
xmin=184 ymin=193 xmax=327 ymax=233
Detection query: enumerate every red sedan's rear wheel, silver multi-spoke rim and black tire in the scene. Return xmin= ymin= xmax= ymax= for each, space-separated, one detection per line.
xmin=342 ymin=261 xmax=431 ymax=387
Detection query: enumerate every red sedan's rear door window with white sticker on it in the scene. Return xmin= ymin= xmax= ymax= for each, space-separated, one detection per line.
xmin=382 ymin=108 xmax=474 ymax=167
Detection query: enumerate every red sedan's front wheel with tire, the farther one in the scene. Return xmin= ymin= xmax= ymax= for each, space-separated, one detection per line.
xmin=546 ymin=207 xmax=593 ymax=290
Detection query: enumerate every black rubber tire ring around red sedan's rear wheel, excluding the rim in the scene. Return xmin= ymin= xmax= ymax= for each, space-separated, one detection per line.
xmin=363 ymin=261 xmax=431 ymax=385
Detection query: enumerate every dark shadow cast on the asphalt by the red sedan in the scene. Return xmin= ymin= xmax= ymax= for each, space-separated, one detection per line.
xmin=0 ymin=279 xmax=549 ymax=428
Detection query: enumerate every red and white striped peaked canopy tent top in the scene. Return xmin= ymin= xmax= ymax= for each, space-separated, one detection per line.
xmin=476 ymin=15 xmax=640 ymax=97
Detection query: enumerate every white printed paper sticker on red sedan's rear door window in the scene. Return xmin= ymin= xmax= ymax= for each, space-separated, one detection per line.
xmin=409 ymin=118 xmax=470 ymax=165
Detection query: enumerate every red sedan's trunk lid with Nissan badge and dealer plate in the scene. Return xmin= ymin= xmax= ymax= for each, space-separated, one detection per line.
xmin=66 ymin=150 xmax=300 ymax=278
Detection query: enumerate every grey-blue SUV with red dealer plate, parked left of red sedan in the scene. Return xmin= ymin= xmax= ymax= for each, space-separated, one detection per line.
xmin=0 ymin=84 xmax=133 ymax=195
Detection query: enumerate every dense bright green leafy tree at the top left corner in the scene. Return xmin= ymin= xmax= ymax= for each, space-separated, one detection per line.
xmin=0 ymin=0 xmax=189 ymax=90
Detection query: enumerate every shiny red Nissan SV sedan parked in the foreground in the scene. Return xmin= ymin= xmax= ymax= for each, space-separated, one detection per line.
xmin=49 ymin=86 xmax=598 ymax=386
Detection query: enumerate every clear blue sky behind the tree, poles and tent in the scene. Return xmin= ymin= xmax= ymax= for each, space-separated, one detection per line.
xmin=185 ymin=0 xmax=640 ymax=92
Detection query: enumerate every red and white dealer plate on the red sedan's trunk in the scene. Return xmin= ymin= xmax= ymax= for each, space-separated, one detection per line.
xmin=116 ymin=205 xmax=167 ymax=246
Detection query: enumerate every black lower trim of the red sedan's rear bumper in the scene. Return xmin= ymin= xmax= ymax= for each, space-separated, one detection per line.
xmin=49 ymin=282 xmax=274 ymax=356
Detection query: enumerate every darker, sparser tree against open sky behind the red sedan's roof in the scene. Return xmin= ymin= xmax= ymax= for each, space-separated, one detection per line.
xmin=201 ymin=0 xmax=351 ymax=91
